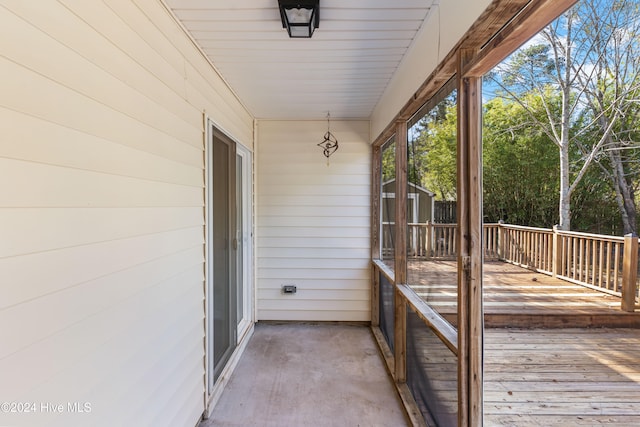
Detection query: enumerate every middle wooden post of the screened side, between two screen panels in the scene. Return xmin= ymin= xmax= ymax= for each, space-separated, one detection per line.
xmin=393 ymin=121 xmax=407 ymax=383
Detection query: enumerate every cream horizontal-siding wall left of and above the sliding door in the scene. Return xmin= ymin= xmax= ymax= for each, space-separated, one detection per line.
xmin=0 ymin=0 xmax=253 ymax=427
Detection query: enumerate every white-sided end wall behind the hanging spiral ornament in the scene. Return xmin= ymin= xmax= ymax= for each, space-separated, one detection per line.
xmin=257 ymin=120 xmax=371 ymax=321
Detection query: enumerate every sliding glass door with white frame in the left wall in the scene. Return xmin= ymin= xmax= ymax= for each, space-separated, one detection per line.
xmin=206 ymin=123 xmax=253 ymax=393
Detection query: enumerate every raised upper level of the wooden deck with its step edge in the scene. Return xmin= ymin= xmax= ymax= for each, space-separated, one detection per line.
xmin=408 ymin=261 xmax=640 ymax=328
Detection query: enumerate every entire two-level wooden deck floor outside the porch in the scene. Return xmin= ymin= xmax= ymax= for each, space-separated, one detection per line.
xmin=408 ymin=261 xmax=640 ymax=427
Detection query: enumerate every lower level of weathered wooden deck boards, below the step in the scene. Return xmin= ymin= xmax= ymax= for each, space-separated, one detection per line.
xmin=484 ymin=328 xmax=640 ymax=426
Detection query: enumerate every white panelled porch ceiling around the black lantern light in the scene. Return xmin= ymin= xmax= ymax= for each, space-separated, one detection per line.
xmin=165 ymin=0 xmax=438 ymax=120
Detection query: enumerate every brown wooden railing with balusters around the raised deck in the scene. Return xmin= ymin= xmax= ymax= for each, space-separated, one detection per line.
xmin=398 ymin=223 xmax=640 ymax=311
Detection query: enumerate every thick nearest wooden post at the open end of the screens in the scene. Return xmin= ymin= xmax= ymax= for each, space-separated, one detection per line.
xmin=457 ymin=49 xmax=484 ymax=427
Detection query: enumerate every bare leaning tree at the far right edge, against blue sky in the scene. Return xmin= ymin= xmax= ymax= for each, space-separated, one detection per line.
xmin=574 ymin=0 xmax=640 ymax=234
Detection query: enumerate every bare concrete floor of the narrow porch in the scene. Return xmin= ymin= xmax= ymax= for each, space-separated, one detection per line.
xmin=200 ymin=323 xmax=409 ymax=427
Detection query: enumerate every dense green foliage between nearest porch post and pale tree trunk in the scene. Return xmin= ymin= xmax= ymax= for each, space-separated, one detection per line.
xmin=483 ymin=98 xmax=559 ymax=227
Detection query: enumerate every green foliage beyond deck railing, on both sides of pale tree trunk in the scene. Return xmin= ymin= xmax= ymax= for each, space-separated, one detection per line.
xmin=483 ymin=93 xmax=621 ymax=234
